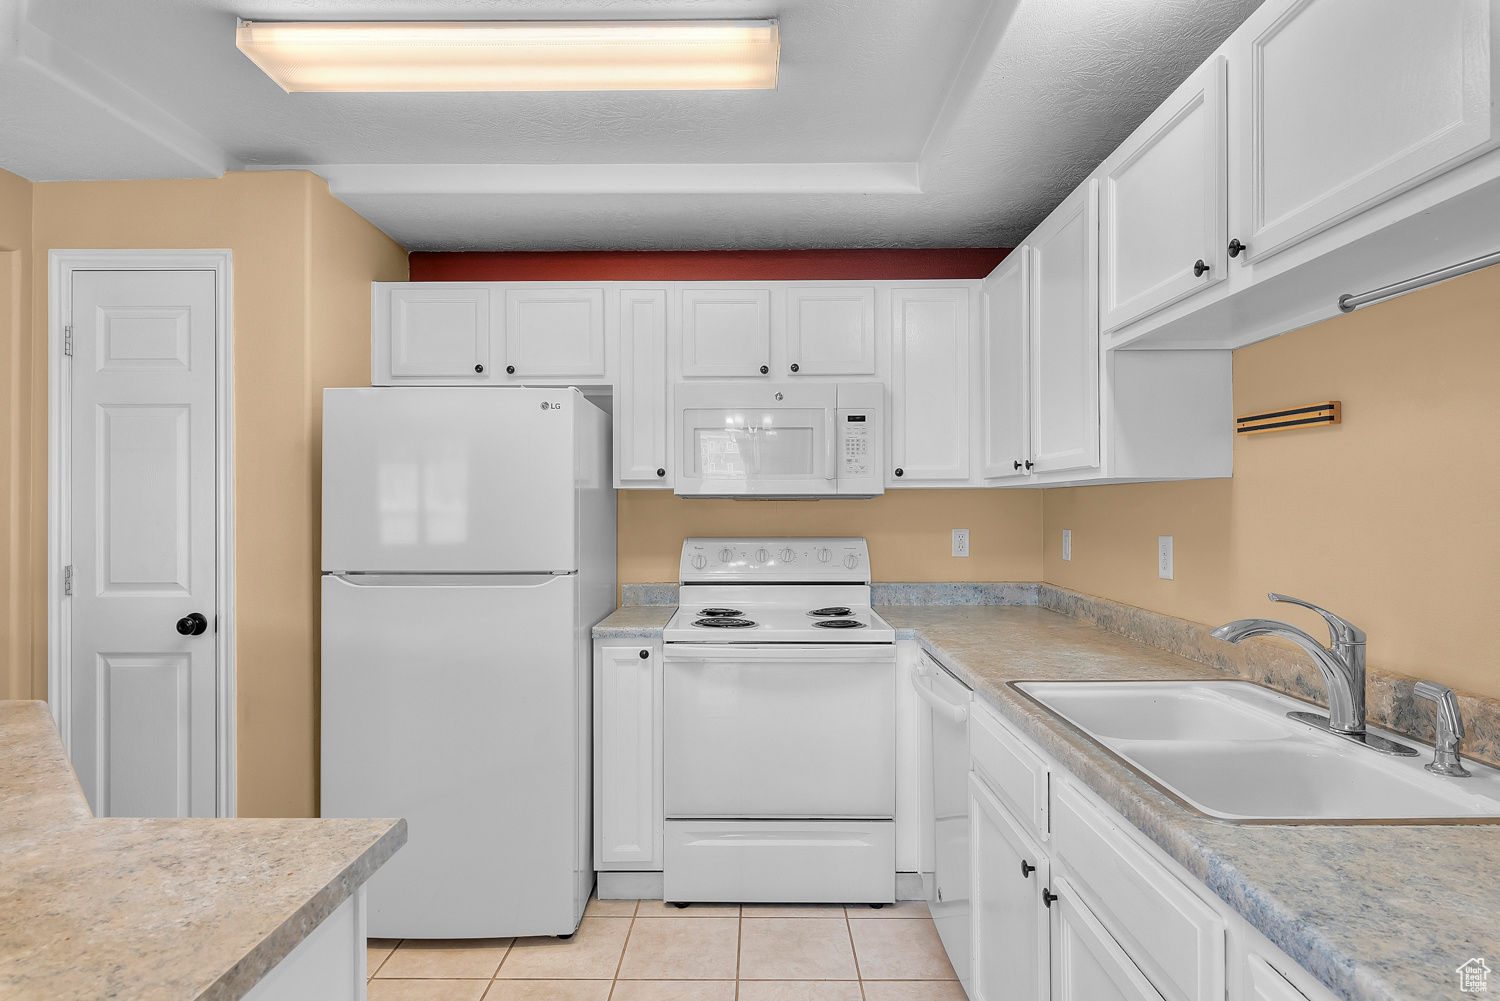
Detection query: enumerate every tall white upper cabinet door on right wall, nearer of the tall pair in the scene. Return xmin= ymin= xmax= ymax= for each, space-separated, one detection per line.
xmin=1026 ymin=177 xmax=1100 ymax=473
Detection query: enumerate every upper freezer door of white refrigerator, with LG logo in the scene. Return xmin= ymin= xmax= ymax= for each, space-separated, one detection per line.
xmin=323 ymin=387 xmax=581 ymax=573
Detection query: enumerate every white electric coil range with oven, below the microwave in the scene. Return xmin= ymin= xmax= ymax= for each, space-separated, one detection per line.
xmin=662 ymin=539 xmax=896 ymax=903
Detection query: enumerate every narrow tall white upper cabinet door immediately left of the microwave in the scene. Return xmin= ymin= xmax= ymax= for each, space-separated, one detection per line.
xmin=615 ymin=288 xmax=672 ymax=488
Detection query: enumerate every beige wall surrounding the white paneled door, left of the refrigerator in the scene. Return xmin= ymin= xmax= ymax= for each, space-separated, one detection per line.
xmin=17 ymin=171 xmax=407 ymax=816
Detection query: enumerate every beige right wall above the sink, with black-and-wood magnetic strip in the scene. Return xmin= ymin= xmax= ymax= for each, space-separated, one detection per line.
xmin=1044 ymin=267 xmax=1500 ymax=696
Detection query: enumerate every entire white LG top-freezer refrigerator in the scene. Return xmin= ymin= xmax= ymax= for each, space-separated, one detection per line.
xmin=321 ymin=387 xmax=615 ymax=938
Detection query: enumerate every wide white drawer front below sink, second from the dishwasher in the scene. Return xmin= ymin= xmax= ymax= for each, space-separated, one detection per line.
xmin=1052 ymin=782 xmax=1224 ymax=1001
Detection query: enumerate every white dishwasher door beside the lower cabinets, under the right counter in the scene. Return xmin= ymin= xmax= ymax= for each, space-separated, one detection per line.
xmin=912 ymin=654 xmax=972 ymax=992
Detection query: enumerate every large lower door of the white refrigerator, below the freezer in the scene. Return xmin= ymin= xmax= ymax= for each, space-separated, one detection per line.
xmin=323 ymin=570 xmax=593 ymax=938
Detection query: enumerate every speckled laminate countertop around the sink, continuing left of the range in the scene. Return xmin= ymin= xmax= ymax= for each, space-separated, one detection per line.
xmin=596 ymin=605 xmax=1500 ymax=1001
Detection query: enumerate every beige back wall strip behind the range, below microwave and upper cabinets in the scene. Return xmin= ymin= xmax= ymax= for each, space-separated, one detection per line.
xmin=618 ymin=489 xmax=1043 ymax=584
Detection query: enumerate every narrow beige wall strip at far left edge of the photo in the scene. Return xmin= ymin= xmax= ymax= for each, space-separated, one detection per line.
xmin=0 ymin=170 xmax=38 ymax=699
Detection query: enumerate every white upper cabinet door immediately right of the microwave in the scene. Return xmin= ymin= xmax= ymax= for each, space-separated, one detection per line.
xmin=887 ymin=288 xmax=971 ymax=486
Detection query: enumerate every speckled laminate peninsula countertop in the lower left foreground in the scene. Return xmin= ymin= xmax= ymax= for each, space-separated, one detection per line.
xmin=0 ymin=701 xmax=407 ymax=1001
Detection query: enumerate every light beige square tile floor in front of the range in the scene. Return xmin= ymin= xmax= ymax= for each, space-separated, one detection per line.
xmin=369 ymin=900 xmax=965 ymax=1001
